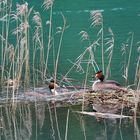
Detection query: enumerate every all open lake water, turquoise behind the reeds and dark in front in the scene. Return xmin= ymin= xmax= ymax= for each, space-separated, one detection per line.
xmin=0 ymin=0 xmax=140 ymax=140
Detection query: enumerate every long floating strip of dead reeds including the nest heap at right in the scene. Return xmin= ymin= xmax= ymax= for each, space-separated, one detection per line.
xmin=1 ymin=88 xmax=140 ymax=116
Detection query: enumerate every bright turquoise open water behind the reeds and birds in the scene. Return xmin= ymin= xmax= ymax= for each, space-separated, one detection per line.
xmin=7 ymin=0 xmax=140 ymax=85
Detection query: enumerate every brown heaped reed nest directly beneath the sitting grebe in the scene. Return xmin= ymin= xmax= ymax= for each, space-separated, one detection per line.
xmin=82 ymin=90 xmax=140 ymax=116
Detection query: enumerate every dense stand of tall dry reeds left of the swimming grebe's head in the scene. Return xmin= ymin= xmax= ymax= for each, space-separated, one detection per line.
xmin=0 ymin=0 xmax=67 ymax=93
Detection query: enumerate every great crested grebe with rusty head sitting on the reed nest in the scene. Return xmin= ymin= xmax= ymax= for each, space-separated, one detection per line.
xmin=92 ymin=71 xmax=126 ymax=92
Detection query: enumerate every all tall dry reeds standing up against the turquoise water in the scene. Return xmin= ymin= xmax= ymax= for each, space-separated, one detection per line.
xmin=0 ymin=0 xmax=139 ymax=92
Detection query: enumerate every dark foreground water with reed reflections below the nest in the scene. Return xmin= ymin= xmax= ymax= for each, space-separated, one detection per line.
xmin=0 ymin=102 xmax=140 ymax=140
